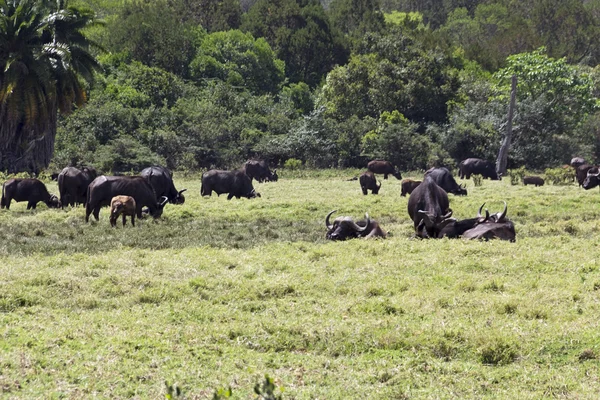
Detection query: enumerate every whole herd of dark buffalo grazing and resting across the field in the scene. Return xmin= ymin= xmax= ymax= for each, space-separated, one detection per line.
xmin=0 ymin=157 xmax=600 ymax=241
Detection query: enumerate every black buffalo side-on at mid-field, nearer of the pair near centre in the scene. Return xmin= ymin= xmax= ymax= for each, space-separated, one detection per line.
xmin=200 ymin=169 xmax=260 ymax=200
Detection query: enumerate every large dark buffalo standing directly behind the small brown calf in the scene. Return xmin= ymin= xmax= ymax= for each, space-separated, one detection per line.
xmin=85 ymin=175 xmax=169 ymax=222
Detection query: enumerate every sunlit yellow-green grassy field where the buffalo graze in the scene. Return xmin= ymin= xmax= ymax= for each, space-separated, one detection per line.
xmin=0 ymin=171 xmax=600 ymax=399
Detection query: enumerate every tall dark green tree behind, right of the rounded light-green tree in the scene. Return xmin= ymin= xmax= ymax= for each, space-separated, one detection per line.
xmin=242 ymin=0 xmax=348 ymax=88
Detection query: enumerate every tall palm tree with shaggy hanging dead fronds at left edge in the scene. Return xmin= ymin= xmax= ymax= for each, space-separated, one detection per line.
xmin=0 ymin=0 xmax=100 ymax=172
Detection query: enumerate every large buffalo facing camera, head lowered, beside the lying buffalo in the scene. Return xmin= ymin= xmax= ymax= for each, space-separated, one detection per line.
xmin=408 ymin=175 xmax=456 ymax=238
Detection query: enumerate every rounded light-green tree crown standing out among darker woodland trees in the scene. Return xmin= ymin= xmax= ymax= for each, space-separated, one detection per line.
xmin=190 ymin=30 xmax=285 ymax=94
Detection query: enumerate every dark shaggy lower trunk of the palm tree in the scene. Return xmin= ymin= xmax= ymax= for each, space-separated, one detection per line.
xmin=0 ymin=108 xmax=57 ymax=174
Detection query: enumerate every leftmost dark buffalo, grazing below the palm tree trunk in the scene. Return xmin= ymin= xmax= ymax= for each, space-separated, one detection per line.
xmin=0 ymin=178 xmax=61 ymax=210
